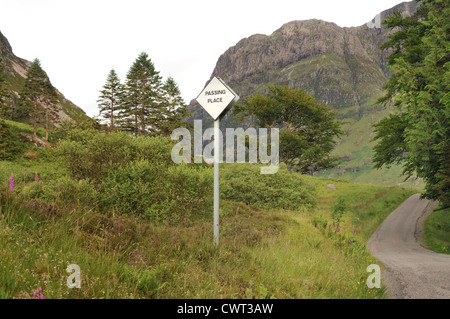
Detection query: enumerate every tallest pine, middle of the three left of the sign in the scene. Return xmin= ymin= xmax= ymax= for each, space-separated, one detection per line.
xmin=120 ymin=52 xmax=164 ymax=134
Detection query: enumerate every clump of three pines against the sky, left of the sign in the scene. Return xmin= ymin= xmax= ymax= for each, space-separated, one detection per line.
xmin=98 ymin=52 xmax=188 ymax=136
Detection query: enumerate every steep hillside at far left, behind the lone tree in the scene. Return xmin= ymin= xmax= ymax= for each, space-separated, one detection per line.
xmin=0 ymin=32 xmax=90 ymax=126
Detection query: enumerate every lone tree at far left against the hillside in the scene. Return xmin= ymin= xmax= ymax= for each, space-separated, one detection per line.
xmin=20 ymin=59 xmax=57 ymax=141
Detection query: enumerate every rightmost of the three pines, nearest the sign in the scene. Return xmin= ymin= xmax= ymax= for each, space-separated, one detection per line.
xmin=159 ymin=77 xmax=189 ymax=136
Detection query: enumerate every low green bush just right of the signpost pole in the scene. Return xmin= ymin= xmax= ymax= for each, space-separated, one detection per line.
xmin=220 ymin=164 xmax=316 ymax=210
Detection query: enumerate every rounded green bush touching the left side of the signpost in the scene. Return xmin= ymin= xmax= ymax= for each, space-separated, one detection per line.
xmin=102 ymin=160 xmax=212 ymax=224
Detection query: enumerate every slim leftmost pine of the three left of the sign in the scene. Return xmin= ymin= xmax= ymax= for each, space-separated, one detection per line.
xmin=97 ymin=69 xmax=122 ymax=130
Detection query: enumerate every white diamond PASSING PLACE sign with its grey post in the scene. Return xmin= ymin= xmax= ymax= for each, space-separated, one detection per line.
xmin=196 ymin=77 xmax=239 ymax=245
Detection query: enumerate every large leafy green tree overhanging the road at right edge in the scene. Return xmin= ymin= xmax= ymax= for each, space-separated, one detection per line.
xmin=374 ymin=0 xmax=450 ymax=206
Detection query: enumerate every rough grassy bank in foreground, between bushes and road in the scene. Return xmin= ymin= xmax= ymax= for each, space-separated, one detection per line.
xmin=0 ymin=167 xmax=412 ymax=298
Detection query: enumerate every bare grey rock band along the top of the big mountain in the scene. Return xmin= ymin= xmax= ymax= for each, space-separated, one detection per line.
xmin=211 ymin=1 xmax=417 ymax=91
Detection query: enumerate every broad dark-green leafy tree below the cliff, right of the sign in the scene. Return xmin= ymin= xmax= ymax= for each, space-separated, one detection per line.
xmin=233 ymin=85 xmax=342 ymax=173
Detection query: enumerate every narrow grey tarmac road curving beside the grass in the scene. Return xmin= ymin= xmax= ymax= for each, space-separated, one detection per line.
xmin=367 ymin=194 xmax=450 ymax=299
